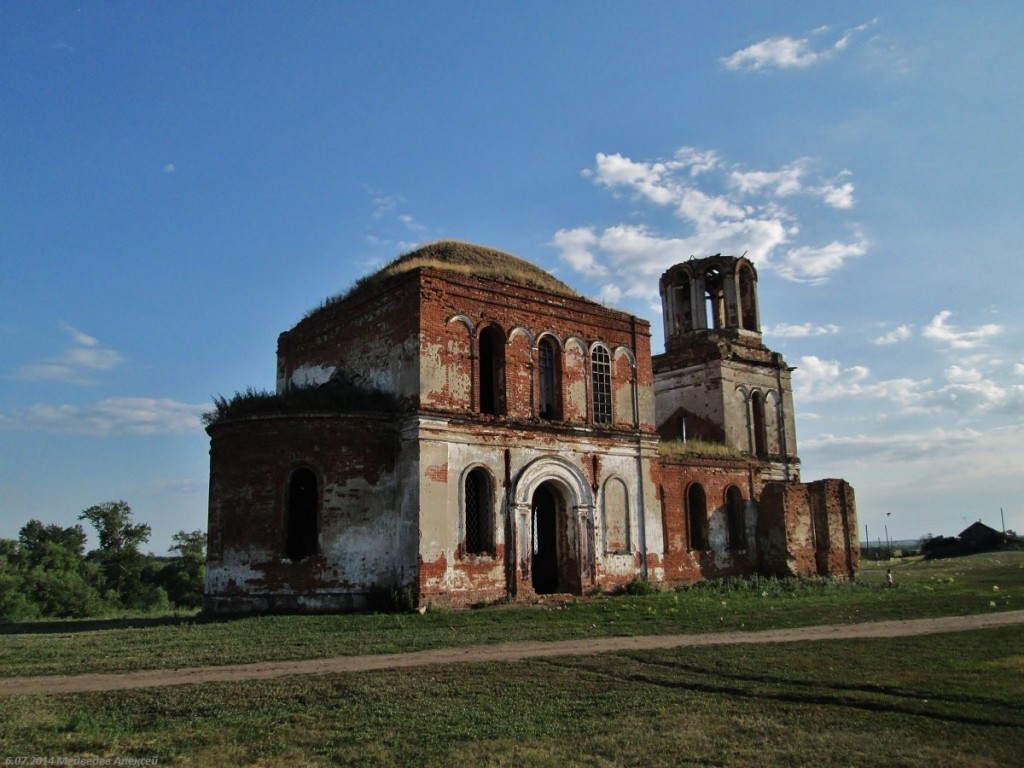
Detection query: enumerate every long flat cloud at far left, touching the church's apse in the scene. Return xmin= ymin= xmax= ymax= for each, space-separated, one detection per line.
xmin=0 ymin=397 xmax=211 ymax=437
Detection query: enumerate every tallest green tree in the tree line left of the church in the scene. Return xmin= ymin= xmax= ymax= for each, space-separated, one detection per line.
xmin=79 ymin=501 xmax=151 ymax=608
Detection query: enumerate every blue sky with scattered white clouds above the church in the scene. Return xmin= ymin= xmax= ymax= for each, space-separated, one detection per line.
xmin=0 ymin=0 xmax=1024 ymax=553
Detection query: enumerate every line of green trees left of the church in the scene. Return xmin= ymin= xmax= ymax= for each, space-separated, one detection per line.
xmin=0 ymin=501 xmax=206 ymax=622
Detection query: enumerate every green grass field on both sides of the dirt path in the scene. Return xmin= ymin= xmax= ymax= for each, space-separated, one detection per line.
xmin=0 ymin=553 xmax=1024 ymax=766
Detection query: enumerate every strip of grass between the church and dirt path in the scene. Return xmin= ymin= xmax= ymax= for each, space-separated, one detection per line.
xmin=0 ymin=552 xmax=1024 ymax=677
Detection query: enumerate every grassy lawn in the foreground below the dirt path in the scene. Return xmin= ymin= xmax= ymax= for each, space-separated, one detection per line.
xmin=0 ymin=627 xmax=1024 ymax=768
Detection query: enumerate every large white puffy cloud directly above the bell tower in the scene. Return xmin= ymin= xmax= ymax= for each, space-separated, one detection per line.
xmin=551 ymin=146 xmax=868 ymax=299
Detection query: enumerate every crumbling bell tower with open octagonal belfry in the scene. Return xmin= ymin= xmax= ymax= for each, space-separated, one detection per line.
xmin=653 ymin=254 xmax=800 ymax=480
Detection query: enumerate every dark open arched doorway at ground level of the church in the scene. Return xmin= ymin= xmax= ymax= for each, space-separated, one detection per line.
xmin=529 ymin=480 xmax=580 ymax=595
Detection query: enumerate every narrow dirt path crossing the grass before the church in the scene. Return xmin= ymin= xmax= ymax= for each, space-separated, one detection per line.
xmin=0 ymin=610 xmax=1024 ymax=696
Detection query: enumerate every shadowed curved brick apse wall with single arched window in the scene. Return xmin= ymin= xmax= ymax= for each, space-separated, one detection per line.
xmin=207 ymin=414 xmax=407 ymax=610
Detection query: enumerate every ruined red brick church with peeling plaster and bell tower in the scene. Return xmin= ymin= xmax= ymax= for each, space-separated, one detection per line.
xmin=205 ymin=242 xmax=859 ymax=612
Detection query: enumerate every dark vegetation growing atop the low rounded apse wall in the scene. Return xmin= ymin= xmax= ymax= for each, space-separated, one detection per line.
xmin=203 ymin=377 xmax=401 ymax=426
